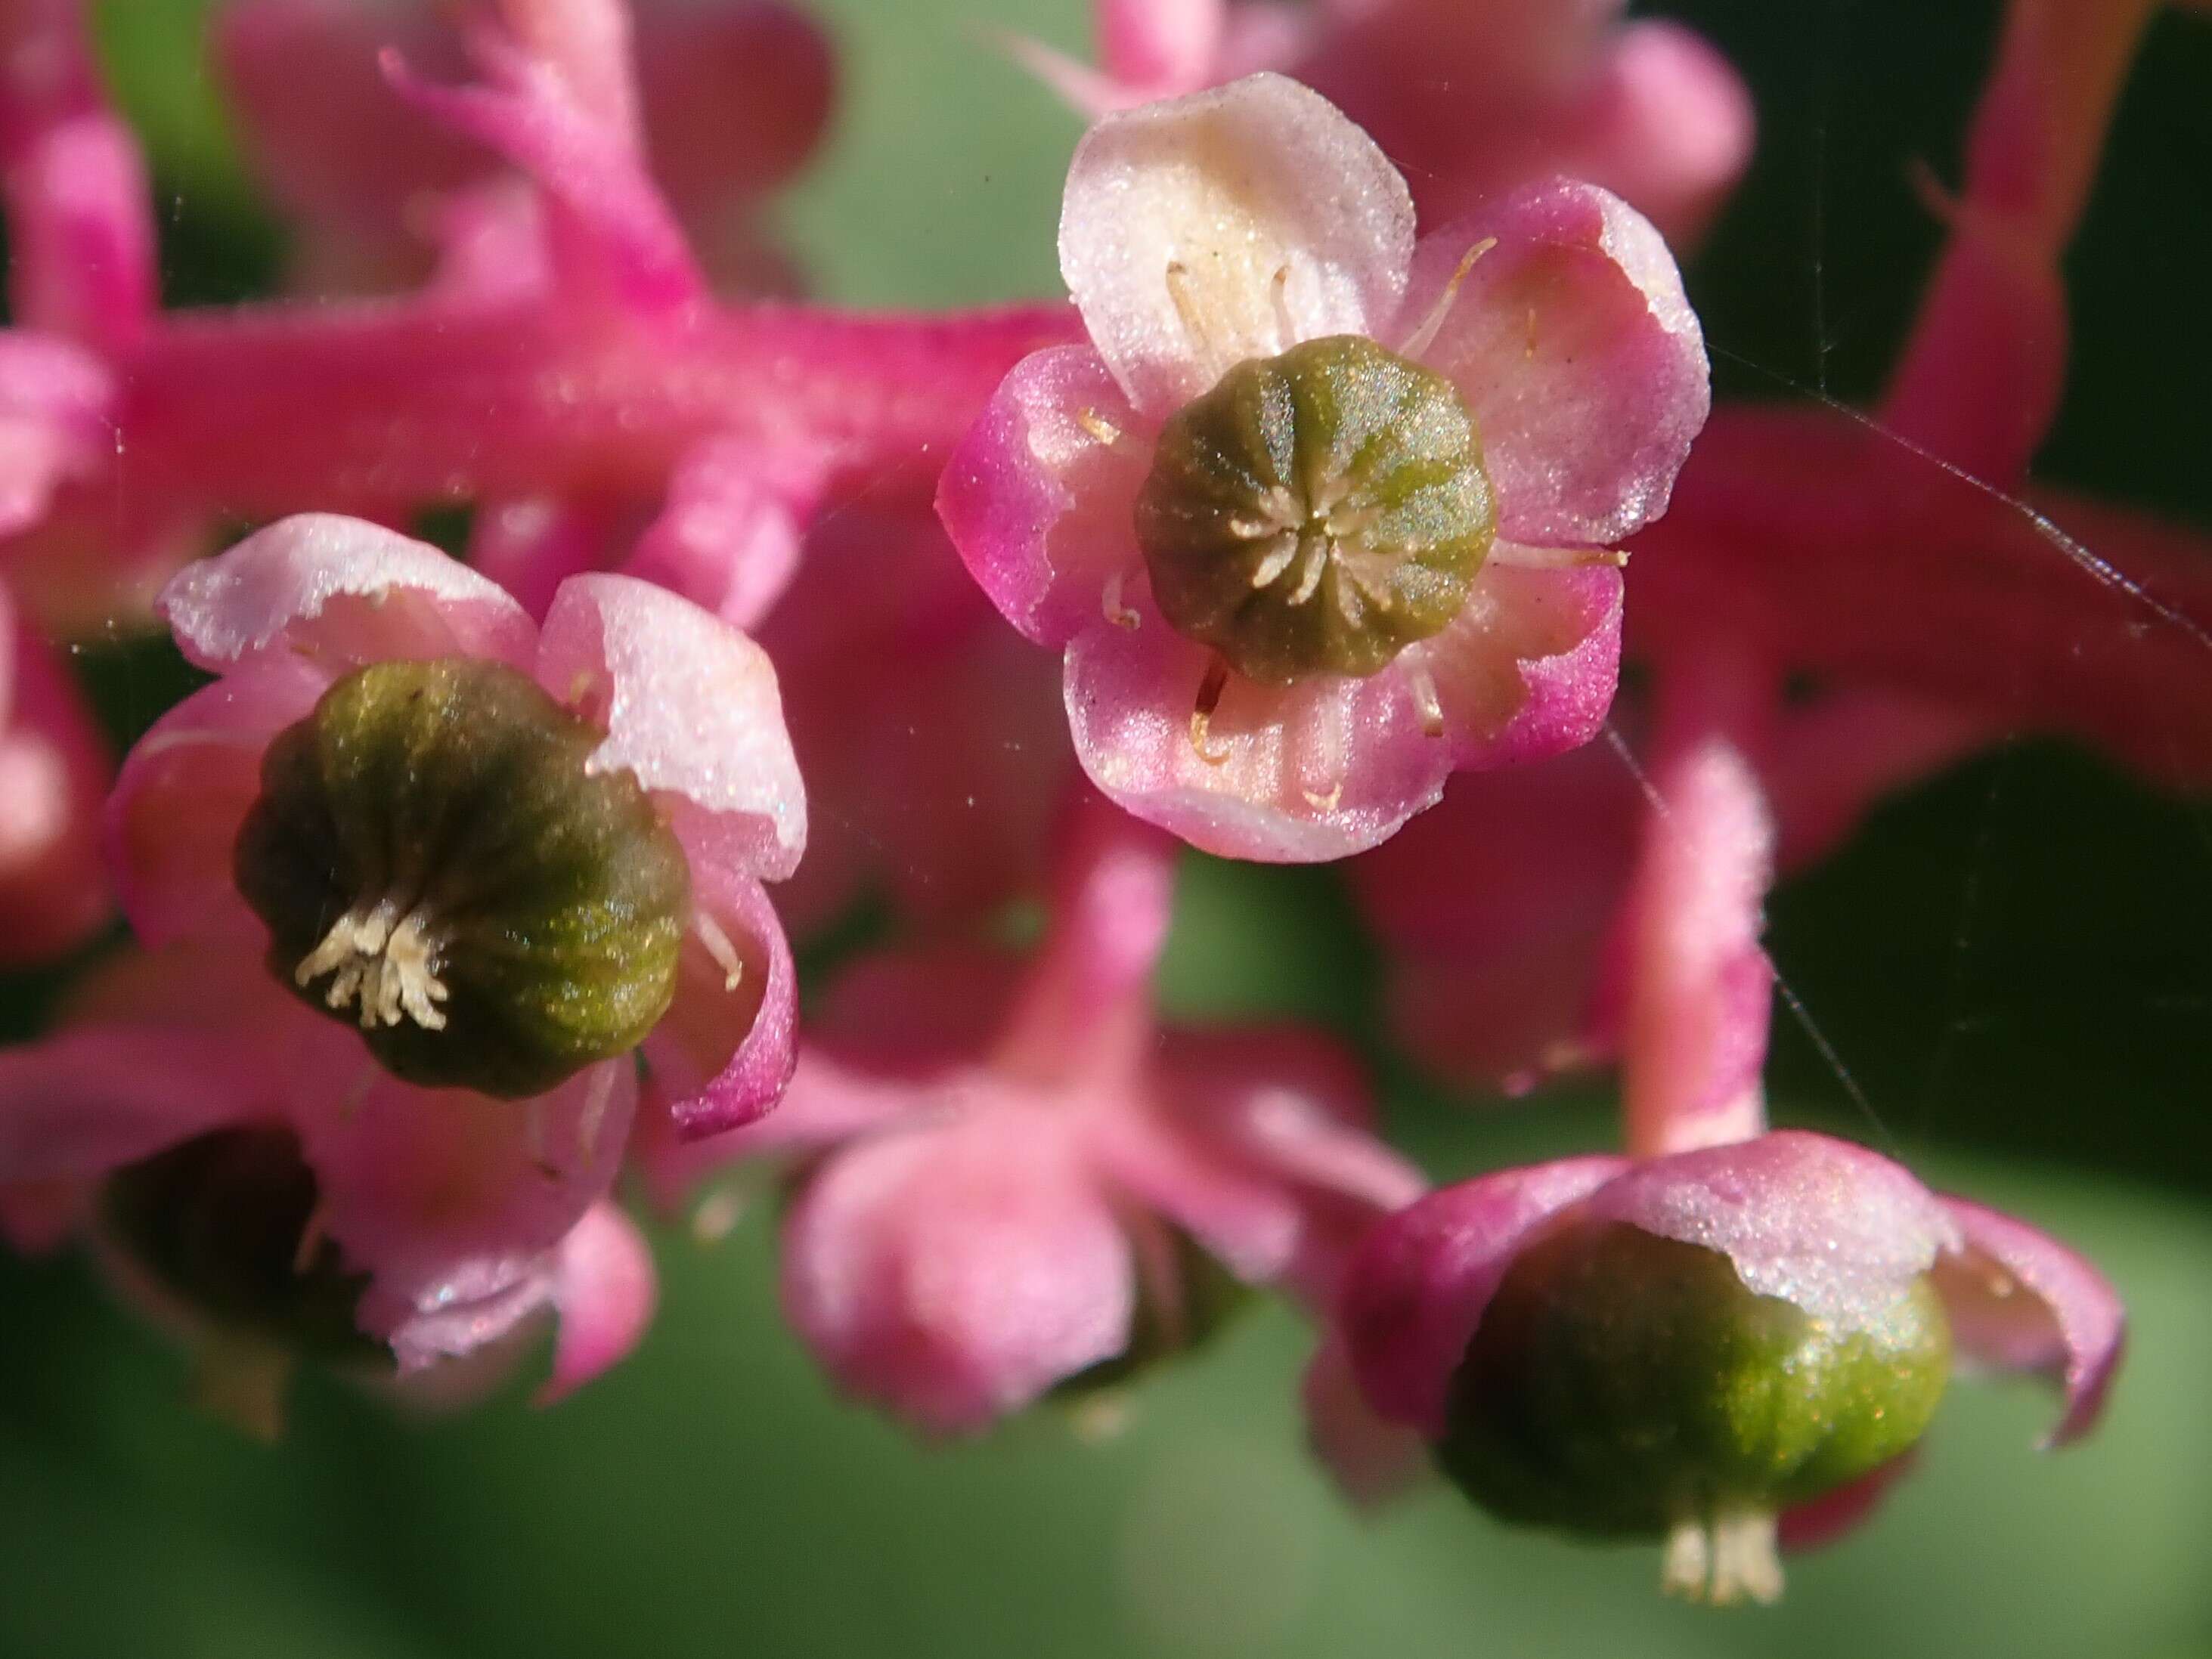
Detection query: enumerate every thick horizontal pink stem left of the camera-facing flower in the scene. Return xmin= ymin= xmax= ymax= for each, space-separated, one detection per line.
xmin=23 ymin=303 xmax=1077 ymax=552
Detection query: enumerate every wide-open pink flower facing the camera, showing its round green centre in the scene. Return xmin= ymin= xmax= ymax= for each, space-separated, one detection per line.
xmin=938 ymin=76 xmax=1710 ymax=860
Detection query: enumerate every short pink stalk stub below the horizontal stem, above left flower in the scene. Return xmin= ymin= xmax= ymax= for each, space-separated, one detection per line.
xmin=621 ymin=440 xmax=823 ymax=628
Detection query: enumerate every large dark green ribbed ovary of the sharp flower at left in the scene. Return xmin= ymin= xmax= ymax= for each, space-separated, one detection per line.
xmin=232 ymin=657 xmax=690 ymax=1097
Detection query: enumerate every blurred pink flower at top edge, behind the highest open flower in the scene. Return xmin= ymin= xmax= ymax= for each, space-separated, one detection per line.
xmin=1018 ymin=0 xmax=1752 ymax=246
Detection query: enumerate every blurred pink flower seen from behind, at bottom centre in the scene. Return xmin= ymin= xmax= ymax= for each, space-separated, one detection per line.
xmin=643 ymin=805 xmax=1422 ymax=1433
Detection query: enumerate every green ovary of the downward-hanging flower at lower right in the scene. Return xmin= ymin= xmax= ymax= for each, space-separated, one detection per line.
xmin=1436 ymin=1223 xmax=1951 ymax=1537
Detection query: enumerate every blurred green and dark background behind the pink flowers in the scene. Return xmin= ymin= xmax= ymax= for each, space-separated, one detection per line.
xmin=0 ymin=0 xmax=2212 ymax=1659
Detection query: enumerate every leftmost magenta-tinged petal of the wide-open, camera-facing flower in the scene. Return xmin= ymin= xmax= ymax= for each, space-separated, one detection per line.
xmin=938 ymin=345 xmax=1151 ymax=646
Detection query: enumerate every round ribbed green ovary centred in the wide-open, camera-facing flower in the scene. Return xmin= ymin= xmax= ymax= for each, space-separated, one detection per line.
xmin=1135 ymin=334 xmax=1495 ymax=686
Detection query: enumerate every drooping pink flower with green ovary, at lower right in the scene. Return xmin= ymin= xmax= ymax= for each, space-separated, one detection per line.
xmin=1338 ymin=1131 xmax=2124 ymax=1602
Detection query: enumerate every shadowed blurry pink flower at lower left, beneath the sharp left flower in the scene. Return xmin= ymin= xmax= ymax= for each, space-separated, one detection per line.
xmin=0 ymin=945 xmax=652 ymax=1433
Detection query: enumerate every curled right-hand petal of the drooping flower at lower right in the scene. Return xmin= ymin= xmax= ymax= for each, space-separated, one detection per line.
xmin=1935 ymin=1199 xmax=2128 ymax=1447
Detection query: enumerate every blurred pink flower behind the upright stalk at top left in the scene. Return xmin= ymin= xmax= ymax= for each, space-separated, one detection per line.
xmin=212 ymin=0 xmax=834 ymax=292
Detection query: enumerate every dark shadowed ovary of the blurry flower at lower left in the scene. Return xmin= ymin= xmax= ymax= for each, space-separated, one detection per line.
xmin=100 ymin=1126 xmax=392 ymax=1367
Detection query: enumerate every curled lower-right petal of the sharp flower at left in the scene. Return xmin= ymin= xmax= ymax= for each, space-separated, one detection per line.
xmin=643 ymin=856 xmax=798 ymax=1137
